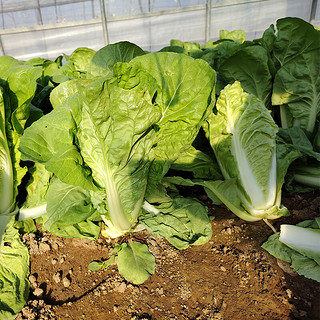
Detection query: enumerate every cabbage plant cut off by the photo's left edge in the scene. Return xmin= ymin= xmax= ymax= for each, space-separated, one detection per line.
xmin=0 ymin=57 xmax=42 ymax=319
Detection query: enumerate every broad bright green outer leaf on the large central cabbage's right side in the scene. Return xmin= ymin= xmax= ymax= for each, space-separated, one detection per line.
xmin=130 ymin=52 xmax=216 ymax=189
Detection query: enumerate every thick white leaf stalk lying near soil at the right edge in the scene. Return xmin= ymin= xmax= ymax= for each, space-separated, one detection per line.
xmin=279 ymin=224 xmax=320 ymax=252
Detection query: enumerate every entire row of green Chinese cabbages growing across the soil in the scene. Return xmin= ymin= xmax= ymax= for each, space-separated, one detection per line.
xmin=0 ymin=18 xmax=320 ymax=319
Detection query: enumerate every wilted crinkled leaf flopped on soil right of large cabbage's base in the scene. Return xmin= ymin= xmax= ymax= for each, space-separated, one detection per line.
xmin=139 ymin=197 xmax=212 ymax=249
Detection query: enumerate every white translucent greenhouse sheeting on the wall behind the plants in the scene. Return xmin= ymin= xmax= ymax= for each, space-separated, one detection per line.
xmin=0 ymin=0 xmax=320 ymax=60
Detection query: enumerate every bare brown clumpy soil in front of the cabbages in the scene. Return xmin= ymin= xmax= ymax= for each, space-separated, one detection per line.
xmin=17 ymin=193 xmax=320 ymax=320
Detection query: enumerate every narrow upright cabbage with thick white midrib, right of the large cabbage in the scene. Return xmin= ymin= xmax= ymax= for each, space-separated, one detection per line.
xmin=165 ymin=82 xmax=299 ymax=221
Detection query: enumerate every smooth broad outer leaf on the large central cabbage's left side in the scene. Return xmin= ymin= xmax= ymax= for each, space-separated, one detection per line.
xmin=20 ymin=96 xmax=96 ymax=190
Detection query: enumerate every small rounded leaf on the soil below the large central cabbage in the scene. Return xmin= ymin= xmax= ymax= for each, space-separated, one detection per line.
xmin=117 ymin=242 xmax=155 ymax=284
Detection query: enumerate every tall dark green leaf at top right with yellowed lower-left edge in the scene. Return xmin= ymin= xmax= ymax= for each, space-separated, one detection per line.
xmin=272 ymin=18 xmax=320 ymax=133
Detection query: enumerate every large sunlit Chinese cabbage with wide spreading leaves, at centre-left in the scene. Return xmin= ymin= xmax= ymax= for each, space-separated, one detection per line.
xmin=20 ymin=51 xmax=216 ymax=283
